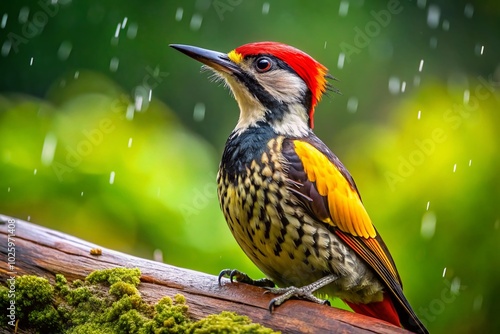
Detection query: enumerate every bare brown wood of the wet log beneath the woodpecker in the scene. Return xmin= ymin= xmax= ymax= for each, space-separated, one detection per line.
xmin=0 ymin=215 xmax=408 ymax=333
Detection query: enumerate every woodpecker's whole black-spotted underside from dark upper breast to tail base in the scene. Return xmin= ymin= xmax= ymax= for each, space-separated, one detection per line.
xmin=218 ymin=125 xmax=383 ymax=303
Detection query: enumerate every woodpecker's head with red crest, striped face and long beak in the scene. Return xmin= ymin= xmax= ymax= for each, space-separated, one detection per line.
xmin=170 ymin=42 xmax=332 ymax=137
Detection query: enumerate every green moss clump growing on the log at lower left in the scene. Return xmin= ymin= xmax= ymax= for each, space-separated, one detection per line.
xmin=0 ymin=268 xmax=275 ymax=334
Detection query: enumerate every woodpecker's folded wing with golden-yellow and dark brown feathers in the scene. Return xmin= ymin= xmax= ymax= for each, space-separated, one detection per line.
xmin=283 ymin=136 xmax=404 ymax=298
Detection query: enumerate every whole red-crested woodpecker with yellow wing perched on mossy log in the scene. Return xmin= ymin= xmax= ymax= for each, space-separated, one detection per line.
xmin=170 ymin=42 xmax=428 ymax=333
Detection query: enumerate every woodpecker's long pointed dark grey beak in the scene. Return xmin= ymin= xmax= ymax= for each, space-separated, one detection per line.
xmin=170 ymin=44 xmax=240 ymax=74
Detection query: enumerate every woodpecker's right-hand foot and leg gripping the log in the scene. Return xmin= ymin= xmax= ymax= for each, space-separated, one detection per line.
xmin=266 ymin=275 xmax=337 ymax=312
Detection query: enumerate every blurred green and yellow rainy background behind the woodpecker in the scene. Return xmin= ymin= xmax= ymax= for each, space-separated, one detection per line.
xmin=0 ymin=0 xmax=500 ymax=333
